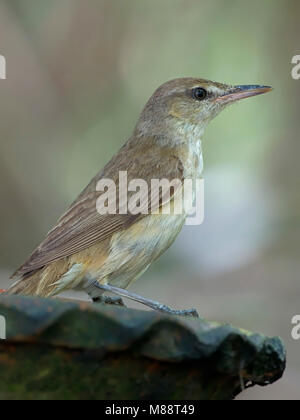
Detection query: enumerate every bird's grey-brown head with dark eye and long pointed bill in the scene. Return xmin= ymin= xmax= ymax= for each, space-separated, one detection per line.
xmin=137 ymin=78 xmax=272 ymax=138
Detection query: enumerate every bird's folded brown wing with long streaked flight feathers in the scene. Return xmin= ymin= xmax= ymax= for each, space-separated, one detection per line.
xmin=13 ymin=138 xmax=183 ymax=278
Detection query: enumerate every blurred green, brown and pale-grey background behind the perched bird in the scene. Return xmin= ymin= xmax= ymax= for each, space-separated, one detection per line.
xmin=0 ymin=0 xmax=300 ymax=400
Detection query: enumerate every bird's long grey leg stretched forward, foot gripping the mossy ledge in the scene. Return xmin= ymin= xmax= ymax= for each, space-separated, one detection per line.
xmin=93 ymin=282 xmax=199 ymax=318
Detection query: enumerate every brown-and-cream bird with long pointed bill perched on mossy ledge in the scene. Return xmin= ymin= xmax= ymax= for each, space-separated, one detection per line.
xmin=7 ymin=77 xmax=272 ymax=317
